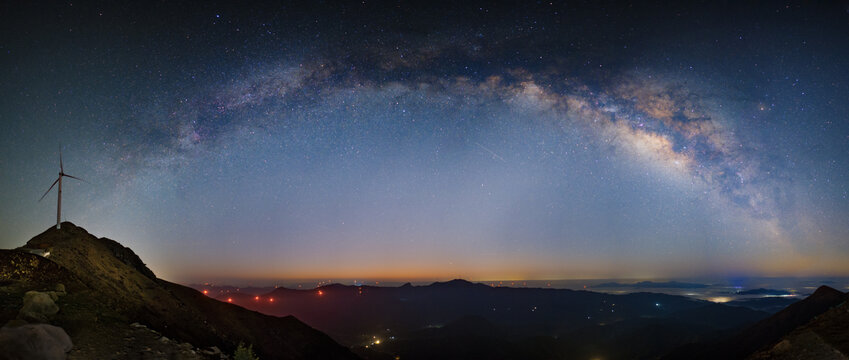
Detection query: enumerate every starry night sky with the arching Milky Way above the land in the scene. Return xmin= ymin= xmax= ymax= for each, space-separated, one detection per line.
xmin=0 ymin=1 xmax=849 ymax=282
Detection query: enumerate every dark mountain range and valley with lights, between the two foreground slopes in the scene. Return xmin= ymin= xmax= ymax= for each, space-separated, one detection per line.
xmin=217 ymin=280 xmax=849 ymax=359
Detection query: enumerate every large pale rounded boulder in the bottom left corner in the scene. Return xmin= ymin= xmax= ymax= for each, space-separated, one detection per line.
xmin=0 ymin=324 xmax=74 ymax=360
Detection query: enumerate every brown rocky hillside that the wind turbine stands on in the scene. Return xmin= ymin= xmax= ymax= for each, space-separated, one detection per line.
xmin=0 ymin=222 xmax=356 ymax=359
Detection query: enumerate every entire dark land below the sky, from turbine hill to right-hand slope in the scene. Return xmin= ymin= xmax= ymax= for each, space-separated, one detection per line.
xmin=0 ymin=223 xmax=849 ymax=360
